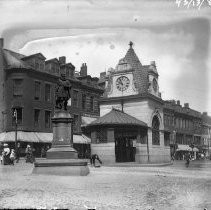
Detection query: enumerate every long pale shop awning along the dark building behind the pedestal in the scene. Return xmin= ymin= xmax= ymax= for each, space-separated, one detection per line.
xmin=0 ymin=131 xmax=91 ymax=144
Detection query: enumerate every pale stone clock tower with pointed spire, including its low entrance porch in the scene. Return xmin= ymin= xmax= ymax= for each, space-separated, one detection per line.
xmin=91 ymin=42 xmax=170 ymax=163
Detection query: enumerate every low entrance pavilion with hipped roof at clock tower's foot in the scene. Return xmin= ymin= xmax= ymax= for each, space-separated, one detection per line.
xmin=86 ymin=108 xmax=148 ymax=163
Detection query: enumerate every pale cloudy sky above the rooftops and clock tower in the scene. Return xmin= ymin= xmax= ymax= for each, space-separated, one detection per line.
xmin=0 ymin=0 xmax=211 ymax=115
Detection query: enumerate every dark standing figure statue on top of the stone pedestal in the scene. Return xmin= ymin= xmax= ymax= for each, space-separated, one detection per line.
xmin=55 ymin=74 xmax=71 ymax=110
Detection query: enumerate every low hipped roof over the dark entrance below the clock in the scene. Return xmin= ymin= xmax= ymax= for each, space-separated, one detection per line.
xmin=87 ymin=109 xmax=147 ymax=127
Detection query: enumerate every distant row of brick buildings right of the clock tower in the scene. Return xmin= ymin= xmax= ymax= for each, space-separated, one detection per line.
xmin=164 ymin=100 xmax=210 ymax=159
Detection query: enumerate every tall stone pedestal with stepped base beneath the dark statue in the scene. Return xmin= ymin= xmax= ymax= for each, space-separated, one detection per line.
xmin=33 ymin=110 xmax=89 ymax=176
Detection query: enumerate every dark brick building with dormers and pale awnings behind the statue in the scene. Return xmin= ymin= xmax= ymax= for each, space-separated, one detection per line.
xmin=0 ymin=39 xmax=103 ymax=156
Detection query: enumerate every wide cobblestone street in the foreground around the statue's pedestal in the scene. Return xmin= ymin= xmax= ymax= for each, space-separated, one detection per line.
xmin=0 ymin=161 xmax=211 ymax=210
